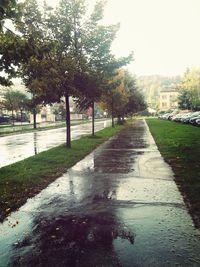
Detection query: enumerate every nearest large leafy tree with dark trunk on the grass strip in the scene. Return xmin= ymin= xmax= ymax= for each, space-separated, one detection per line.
xmin=19 ymin=0 xmax=131 ymax=147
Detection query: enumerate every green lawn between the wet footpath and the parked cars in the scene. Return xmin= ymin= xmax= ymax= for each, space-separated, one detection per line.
xmin=146 ymin=119 xmax=200 ymax=227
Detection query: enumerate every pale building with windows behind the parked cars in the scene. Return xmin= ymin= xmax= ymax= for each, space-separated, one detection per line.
xmin=159 ymin=86 xmax=179 ymax=110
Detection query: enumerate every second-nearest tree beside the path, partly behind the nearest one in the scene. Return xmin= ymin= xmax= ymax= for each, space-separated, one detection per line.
xmin=75 ymin=1 xmax=132 ymax=135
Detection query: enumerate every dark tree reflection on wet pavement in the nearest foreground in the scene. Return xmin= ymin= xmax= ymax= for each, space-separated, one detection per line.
xmin=11 ymin=211 xmax=135 ymax=266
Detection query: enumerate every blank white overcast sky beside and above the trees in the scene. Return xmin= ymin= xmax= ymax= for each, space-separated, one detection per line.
xmin=39 ymin=0 xmax=200 ymax=75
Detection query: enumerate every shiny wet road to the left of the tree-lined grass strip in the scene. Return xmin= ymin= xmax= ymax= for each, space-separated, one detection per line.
xmin=0 ymin=120 xmax=111 ymax=168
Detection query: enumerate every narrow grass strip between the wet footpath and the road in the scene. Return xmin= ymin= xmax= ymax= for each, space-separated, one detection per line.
xmin=0 ymin=125 xmax=125 ymax=223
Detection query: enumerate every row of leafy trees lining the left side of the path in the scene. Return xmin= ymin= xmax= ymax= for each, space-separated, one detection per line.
xmin=0 ymin=0 xmax=144 ymax=147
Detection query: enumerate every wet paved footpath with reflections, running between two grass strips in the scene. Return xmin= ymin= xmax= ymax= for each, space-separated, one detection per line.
xmin=0 ymin=121 xmax=200 ymax=267
